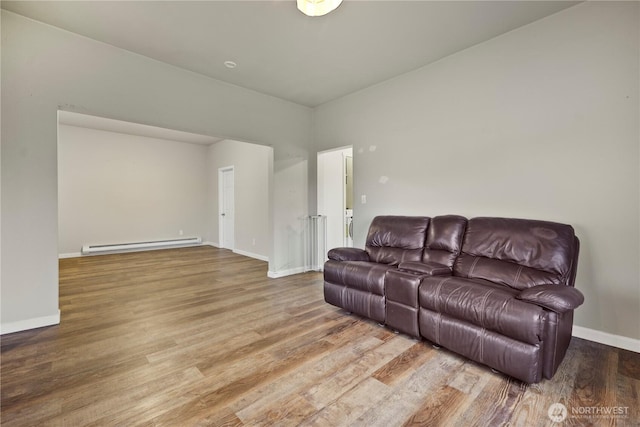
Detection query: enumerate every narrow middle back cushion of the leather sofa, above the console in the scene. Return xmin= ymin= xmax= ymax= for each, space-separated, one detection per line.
xmin=422 ymin=215 xmax=467 ymax=268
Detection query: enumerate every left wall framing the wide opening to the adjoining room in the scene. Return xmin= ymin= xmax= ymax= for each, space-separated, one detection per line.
xmin=0 ymin=10 xmax=312 ymax=333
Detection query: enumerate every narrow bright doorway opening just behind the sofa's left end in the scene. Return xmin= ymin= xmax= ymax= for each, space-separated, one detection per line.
xmin=318 ymin=146 xmax=353 ymax=258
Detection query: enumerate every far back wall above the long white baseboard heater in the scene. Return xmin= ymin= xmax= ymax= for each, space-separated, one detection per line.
xmin=58 ymin=125 xmax=208 ymax=254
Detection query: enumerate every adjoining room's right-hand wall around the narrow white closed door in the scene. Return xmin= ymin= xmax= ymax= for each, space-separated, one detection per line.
xmin=207 ymin=140 xmax=273 ymax=259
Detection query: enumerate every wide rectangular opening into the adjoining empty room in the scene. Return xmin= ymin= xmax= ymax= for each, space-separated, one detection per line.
xmin=57 ymin=111 xmax=274 ymax=261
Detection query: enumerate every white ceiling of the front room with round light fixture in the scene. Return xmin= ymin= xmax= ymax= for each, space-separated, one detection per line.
xmin=1 ymin=0 xmax=578 ymax=107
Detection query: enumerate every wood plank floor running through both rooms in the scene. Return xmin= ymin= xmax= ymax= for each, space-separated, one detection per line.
xmin=0 ymin=246 xmax=640 ymax=427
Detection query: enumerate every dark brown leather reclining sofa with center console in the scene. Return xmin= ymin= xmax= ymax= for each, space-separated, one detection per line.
xmin=324 ymin=215 xmax=584 ymax=383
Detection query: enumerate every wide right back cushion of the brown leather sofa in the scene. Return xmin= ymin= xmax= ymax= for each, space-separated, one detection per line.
xmin=454 ymin=218 xmax=577 ymax=289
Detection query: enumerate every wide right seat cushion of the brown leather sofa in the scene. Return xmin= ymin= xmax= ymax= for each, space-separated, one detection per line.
xmin=418 ymin=276 xmax=545 ymax=344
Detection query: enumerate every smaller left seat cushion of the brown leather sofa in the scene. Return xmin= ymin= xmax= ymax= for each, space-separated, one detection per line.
xmin=324 ymin=260 xmax=396 ymax=295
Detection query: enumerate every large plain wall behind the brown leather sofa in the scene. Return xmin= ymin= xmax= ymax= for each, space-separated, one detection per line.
xmin=314 ymin=2 xmax=640 ymax=340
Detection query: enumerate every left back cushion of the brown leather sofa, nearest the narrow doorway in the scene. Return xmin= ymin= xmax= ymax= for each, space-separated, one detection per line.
xmin=365 ymin=216 xmax=430 ymax=265
